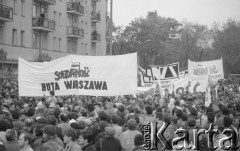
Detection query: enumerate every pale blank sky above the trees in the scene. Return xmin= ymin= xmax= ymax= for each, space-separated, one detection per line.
xmin=112 ymin=0 xmax=240 ymax=27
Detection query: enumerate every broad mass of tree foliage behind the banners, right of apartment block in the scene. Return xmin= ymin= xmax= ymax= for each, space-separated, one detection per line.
xmin=113 ymin=11 xmax=217 ymax=70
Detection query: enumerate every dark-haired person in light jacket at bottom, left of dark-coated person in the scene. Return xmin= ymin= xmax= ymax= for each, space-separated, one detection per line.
xmin=63 ymin=128 xmax=82 ymax=151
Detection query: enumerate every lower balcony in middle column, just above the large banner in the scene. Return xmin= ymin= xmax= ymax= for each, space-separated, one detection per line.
xmin=67 ymin=26 xmax=84 ymax=38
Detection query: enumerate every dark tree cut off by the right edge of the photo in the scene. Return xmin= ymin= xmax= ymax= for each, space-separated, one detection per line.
xmin=213 ymin=20 xmax=240 ymax=73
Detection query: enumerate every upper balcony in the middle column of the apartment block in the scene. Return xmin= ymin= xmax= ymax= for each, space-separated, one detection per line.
xmin=67 ymin=2 xmax=84 ymax=16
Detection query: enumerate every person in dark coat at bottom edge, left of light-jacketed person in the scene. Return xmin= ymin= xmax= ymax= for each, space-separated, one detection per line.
xmin=96 ymin=126 xmax=122 ymax=151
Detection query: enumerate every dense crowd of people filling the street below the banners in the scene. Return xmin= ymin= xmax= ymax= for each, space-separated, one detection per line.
xmin=0 ymin=79 xmax=240 ymax=151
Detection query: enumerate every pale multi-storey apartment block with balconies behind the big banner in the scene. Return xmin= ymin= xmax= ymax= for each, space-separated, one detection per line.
xmin=0 ymin=0 xmax=108 ymax=81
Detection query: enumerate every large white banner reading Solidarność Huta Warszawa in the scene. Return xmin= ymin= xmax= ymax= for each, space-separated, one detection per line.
xmin=18 ymin=53 xmax=137 ymax=96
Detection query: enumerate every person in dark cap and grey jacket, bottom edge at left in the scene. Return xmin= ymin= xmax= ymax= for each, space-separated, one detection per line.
xmin=41 ymin=125 xmax=64 ymax=151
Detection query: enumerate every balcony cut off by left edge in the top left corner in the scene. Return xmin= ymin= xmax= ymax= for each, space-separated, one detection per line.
xmin=0 ymin=4 xmax=13 ymax=22
